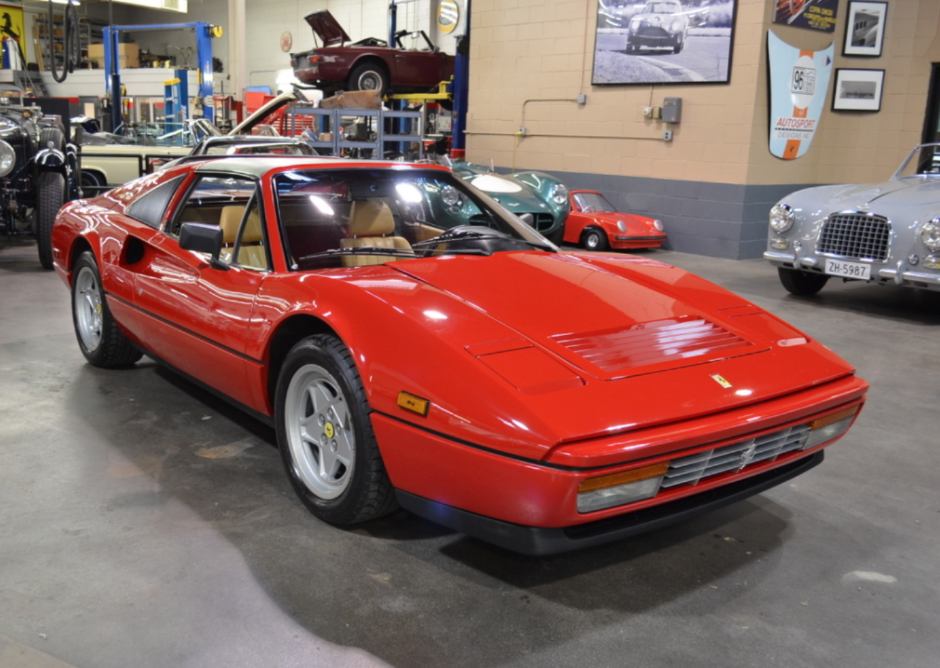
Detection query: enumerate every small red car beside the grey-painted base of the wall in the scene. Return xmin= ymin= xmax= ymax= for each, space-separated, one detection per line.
xmin=563 ymin=190 xmax=666 ymax=250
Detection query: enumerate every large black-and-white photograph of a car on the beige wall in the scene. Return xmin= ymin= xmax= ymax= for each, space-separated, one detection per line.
xmin=592 ymin=0 xmax=738 ymax=86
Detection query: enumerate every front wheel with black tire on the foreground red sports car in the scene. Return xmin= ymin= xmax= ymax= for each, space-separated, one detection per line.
xmin=275 ymin=334 xmax=398 ymax=526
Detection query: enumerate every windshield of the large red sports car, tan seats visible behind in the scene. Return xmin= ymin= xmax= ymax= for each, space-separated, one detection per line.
xmin=274 ymin=168 xmax=555 ymax=270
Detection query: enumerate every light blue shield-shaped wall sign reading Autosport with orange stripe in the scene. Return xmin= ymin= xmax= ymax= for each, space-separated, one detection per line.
xmin=767 ymin=32 xmax=835 ymax=160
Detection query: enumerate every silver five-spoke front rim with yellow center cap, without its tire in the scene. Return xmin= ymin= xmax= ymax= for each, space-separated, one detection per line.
xmin=284 ymin=364 xmax=356 ymax=499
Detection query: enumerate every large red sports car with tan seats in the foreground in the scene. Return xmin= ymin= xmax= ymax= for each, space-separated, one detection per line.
xmin=52 ymin=155 xmax=868 ymax=554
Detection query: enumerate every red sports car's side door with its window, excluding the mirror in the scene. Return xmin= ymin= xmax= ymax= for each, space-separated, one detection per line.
xmin=129 ymin=174 xmax=271 ymax=408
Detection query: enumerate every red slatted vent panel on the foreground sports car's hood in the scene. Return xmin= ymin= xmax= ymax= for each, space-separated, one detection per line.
xmin=552 ymin=317 xmax=747 ymax=372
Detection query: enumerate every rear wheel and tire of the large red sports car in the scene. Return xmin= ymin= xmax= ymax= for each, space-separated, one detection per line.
xmin=72 ymin=251 xmax=143 ymax=368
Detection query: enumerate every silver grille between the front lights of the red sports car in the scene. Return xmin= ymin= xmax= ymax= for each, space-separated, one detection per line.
xmin=662 ymin=424 xmax=810 ymax=488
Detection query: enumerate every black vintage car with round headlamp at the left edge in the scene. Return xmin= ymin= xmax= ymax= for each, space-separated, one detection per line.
xmin=0 ymin=98 xmax=80 ymax=269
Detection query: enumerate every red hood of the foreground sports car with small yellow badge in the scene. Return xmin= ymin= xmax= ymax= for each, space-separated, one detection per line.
xmin=383 ymin=252 xmax=853 ymax=442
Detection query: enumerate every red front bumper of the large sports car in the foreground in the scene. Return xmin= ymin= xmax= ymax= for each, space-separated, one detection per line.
xmin=372 ymin=376 xmax=867 ymax=549
